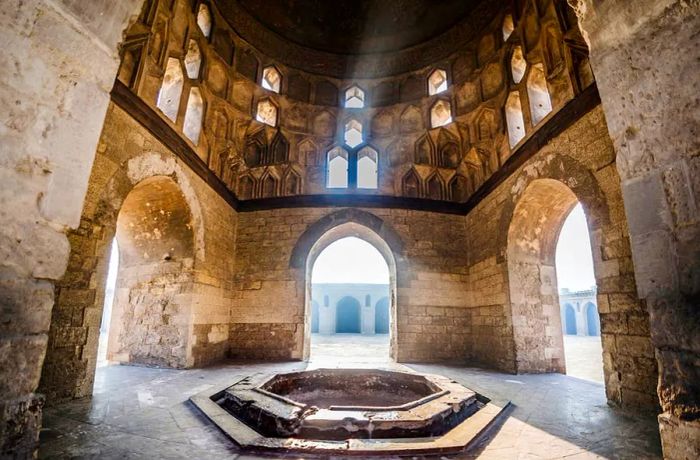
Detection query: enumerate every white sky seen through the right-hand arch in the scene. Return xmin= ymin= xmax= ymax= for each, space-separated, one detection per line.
xmin=556 ymin=204 xmax=595 ymax=291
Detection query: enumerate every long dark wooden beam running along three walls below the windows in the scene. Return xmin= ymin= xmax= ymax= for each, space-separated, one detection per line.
xmin=111 ymin=81 xmax=600 ymax=215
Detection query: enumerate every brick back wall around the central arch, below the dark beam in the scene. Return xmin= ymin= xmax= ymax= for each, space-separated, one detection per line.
xmin=230 ymin=208 xmax=471 ymax=361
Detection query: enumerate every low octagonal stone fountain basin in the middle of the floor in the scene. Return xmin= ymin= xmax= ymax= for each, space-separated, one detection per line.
xmin=191 ymin=369 xmax=504 ymax=455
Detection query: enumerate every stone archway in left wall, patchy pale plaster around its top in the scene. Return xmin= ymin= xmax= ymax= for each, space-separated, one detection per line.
xmin=40 ymin=153 xmax=204 ymax=403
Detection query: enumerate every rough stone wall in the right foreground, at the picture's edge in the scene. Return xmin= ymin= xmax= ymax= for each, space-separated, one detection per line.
xmin=570 ymin=0 xmax=700 ymax=458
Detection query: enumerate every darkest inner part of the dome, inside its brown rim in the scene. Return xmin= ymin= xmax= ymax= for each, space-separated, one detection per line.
xmin=237 ymin=0 xmax=477 ymax=54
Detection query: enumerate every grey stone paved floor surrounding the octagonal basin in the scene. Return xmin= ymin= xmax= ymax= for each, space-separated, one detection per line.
xmin=40 ymin=335 xmax=660 ymax=460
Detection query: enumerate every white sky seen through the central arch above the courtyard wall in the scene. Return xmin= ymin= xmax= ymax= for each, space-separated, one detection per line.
xmin=311 ymin=236 xmax=389 ymax=284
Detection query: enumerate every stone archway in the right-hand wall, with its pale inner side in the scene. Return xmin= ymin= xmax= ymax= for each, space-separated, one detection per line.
xmin=500 ymin=153 xmax=656 ymax=408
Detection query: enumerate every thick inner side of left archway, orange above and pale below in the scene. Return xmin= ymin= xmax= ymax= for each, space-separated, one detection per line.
xmin=107 ymin=176 xmax=194 ymax=367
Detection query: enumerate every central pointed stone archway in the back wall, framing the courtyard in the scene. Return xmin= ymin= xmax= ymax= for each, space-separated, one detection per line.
xmin=290 ymin=209 xmax=407 ymax=359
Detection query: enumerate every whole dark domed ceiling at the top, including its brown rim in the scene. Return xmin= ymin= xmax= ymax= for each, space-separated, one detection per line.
xmin=215 ymin=0 xmax=492 ymax=78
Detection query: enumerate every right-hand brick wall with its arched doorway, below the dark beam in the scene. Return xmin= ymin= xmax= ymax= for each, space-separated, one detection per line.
xmin=466 ymin=107 xmax=656 ymax=408
